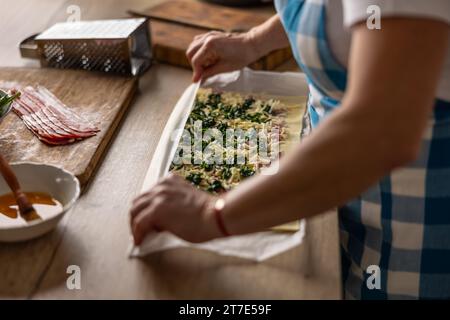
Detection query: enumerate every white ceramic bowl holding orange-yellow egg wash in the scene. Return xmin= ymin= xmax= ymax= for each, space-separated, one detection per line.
xmin=0 ymin=162 xmax=80 ymax=242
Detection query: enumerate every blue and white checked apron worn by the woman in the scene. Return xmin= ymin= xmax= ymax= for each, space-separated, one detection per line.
xmin=276 ymin=0 xmax=450 ymax=299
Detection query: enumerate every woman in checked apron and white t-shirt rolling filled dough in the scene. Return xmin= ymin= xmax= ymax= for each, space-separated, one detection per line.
xmin=131 ymin=0 xmax=450 ymax=299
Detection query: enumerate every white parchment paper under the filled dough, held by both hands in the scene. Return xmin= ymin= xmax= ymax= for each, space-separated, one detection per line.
xmin=129 ymin=68 xmax=308 ymax=261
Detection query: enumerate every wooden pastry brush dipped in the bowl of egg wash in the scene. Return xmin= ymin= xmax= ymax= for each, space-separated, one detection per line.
xmin=0 ymin=154 xmax=39 ymax=220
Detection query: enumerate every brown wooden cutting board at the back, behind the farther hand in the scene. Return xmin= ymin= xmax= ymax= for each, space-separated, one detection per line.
xmin=130 ymin=0 xmax=292 ymax=70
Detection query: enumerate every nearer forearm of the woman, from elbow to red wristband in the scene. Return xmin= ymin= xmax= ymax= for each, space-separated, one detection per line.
xmin=223 ymin=104 xmax=416 ymax=234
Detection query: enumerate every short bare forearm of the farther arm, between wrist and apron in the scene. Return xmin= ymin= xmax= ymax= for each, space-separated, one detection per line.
xmin=247 ymin=15 xmax=289 ymax=56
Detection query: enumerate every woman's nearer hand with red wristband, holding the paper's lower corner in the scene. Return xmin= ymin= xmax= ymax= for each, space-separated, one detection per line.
xmin=130 ymin=175 xmax=222 ymax=245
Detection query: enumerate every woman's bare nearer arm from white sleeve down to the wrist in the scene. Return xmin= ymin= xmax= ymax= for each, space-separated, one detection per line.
xmin=223 ymin=19 xmax=448 ymax=234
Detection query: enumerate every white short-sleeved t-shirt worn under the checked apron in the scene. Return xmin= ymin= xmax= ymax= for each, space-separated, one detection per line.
xmin=326 ymin=0 xmax=450 ymax=101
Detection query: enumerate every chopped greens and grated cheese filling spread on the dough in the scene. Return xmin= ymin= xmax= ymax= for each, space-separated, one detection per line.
xmin=170 ymin=89 xmax=300 ymax=194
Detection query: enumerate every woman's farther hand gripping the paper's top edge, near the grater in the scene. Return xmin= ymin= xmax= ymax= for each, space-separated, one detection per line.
xmin=186 ymin=31 xmax=262 ymax=82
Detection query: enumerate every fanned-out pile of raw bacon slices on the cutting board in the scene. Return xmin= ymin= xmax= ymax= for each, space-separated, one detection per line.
xmin=0 ymin=82 xmax=100 ymax=145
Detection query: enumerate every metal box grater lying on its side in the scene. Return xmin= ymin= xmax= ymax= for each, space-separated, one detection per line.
xmin=20 ymin=18 xmax=152 ymax=76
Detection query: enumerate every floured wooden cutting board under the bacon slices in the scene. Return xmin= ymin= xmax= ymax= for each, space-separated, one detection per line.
xmin=0 ymin=68 xmax=137 ymax=188
